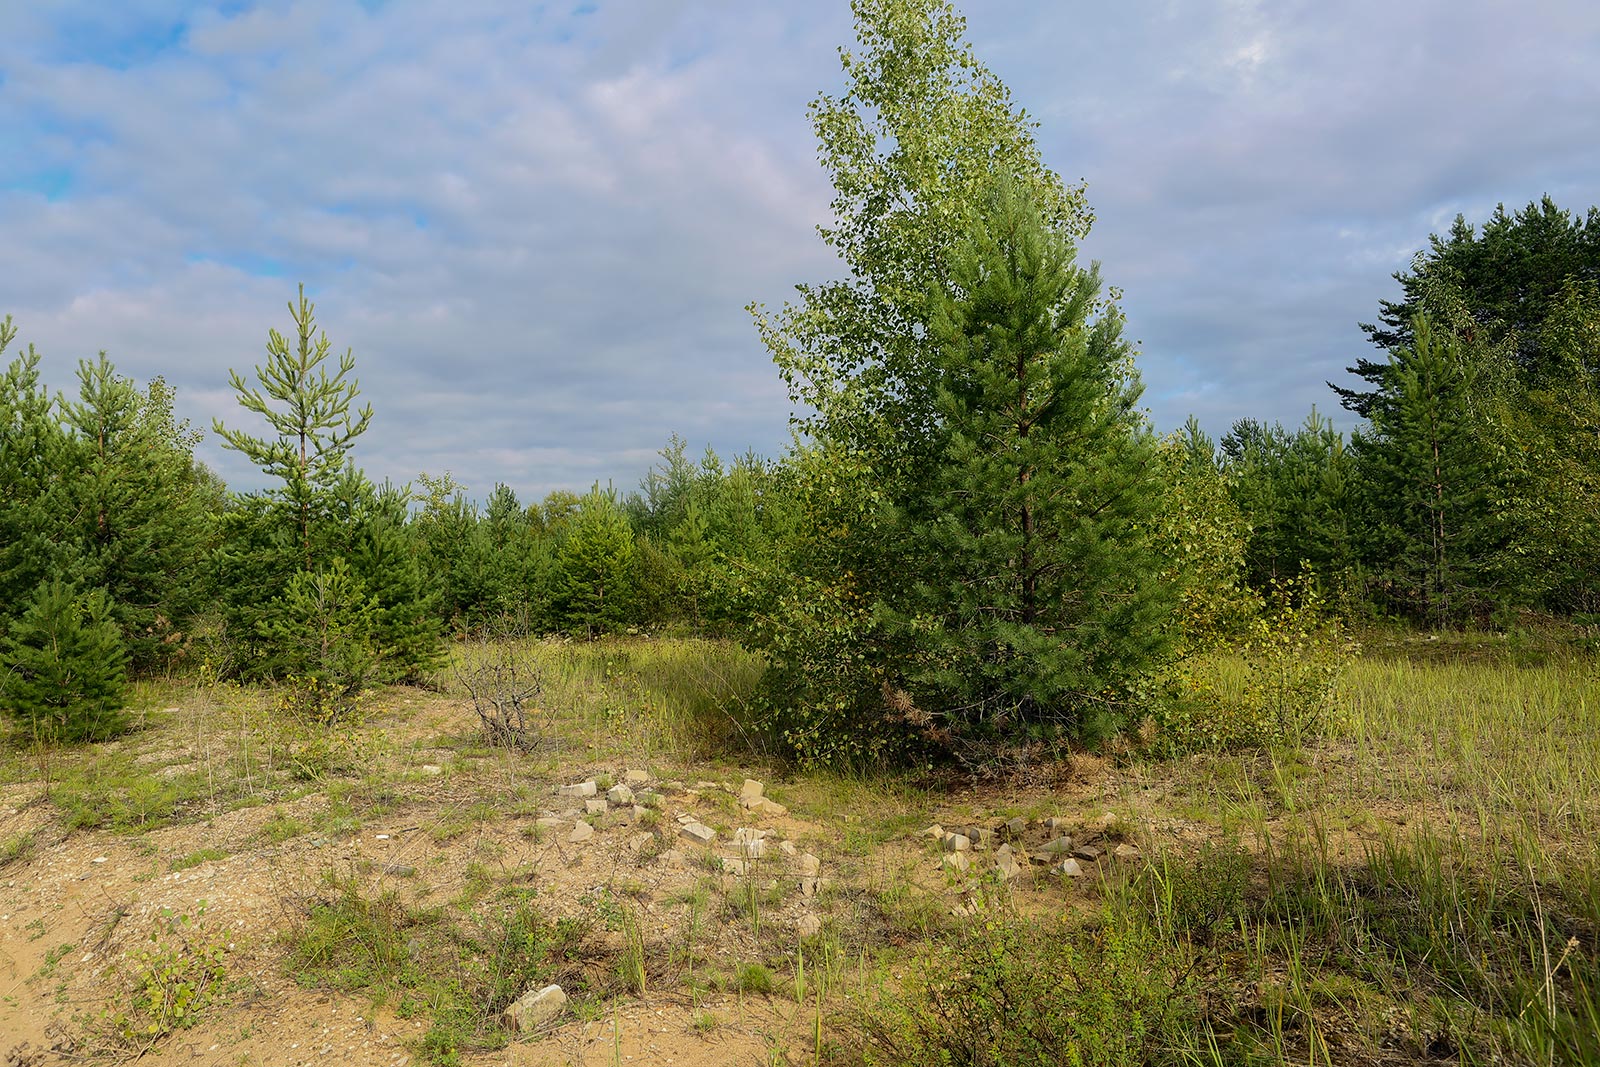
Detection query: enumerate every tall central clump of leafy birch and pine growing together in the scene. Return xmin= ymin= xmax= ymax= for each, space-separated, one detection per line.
xmin=747 ymin=0 xmax=1171 ymax=761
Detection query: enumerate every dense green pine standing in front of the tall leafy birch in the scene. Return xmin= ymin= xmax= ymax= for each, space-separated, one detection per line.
xmin=885 ymin=181 xmax=1174 ymax=748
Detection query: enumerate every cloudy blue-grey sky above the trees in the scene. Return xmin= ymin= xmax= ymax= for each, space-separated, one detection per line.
xmin=0 ymin=0 xmax=1600 ymax=502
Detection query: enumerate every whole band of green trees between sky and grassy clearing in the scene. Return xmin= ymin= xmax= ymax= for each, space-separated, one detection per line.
xmin=0 ymin=0 xmax=1600 ymax=761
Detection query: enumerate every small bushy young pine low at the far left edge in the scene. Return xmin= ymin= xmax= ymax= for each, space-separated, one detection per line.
xmin=0 ymin=579 xmax=126 ymax=742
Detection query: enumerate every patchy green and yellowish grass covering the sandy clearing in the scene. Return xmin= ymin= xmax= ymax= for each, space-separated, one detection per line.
xmin=0 ymin=637 xmax=1600 ymax=1067
